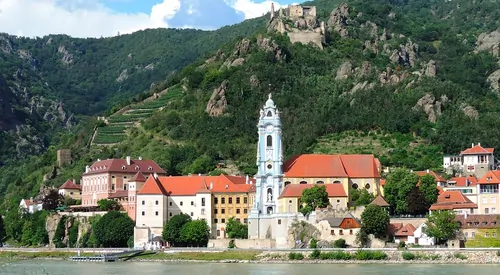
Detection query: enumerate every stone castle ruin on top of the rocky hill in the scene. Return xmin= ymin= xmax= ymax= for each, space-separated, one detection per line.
xmin=268 ymin=4 xmax=325 ymax=49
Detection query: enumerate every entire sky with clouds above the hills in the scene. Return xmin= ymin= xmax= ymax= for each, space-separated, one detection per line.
xmin=0 ymin=0 xmax=302 ymax=37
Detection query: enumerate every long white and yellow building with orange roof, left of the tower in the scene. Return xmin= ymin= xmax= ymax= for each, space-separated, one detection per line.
xmin=134 ymin=175 xmax=255 ymax=246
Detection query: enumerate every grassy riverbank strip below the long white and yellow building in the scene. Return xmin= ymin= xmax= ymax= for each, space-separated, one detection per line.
xmin=137 ymin=251 xmax=260 ymax=261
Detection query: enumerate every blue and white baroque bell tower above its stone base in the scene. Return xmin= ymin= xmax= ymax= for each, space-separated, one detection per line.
xmin=251 ymin=94 xmax=283 ymax=215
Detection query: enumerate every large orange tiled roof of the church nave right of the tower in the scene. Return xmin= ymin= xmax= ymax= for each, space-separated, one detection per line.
xmin=283 ymin=154 xmax=380 ymax=178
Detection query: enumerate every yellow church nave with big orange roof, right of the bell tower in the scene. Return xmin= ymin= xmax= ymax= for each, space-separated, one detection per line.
xmin=283 ymin=154 xmax=381 ymax=206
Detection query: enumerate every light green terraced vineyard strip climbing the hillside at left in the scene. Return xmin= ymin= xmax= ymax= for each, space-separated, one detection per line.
xmin=92 ymin=86 xmax=182 ymax=145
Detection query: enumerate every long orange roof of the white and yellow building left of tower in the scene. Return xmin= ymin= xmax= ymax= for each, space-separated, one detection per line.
xmin=139 ymin=175 xmax=253 ymax=196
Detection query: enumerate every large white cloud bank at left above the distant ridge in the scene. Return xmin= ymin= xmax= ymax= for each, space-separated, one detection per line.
xmin=0 ymin=0 xmax=181 ymax=37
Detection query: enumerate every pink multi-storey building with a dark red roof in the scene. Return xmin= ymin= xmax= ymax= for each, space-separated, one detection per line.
xmin=82 ymin=157 xmax=167 ymax=218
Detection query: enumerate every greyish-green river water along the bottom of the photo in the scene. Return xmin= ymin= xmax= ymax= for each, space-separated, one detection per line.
xmin=0 ymin=260 xmax=500 ymax=275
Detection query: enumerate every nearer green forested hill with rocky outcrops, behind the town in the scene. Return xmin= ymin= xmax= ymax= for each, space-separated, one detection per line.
xmin=0 ymin=0 xmax=500 ymax=206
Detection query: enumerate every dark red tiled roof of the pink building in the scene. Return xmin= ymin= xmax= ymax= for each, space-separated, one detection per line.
xmin=83 ymin=159 xmax=167 ymax=175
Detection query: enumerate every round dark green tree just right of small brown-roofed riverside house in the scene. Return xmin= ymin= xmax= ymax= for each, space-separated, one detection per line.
xmin=361 ymin=204 xmax=389 ymax=236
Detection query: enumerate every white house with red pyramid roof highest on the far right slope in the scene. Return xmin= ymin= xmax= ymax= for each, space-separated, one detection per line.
xmin=443 ymin=143 xmax=497 ymax=178
